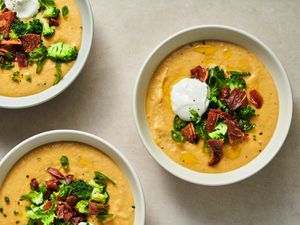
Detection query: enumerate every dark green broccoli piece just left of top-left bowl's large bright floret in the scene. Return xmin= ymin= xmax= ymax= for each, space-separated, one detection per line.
xmin=28 ymin=44 xmax=48 ymax=74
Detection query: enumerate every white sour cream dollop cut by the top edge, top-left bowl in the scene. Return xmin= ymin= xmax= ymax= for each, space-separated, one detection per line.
xmin=5 ymin=0 xmax=40 ymax=19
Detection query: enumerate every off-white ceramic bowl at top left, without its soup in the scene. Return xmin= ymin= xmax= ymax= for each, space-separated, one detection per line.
xmin=0 ymin=0 xmax=94 ymax=109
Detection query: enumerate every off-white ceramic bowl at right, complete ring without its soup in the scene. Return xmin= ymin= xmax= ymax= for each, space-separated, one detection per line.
xmin=133 ymin=25 xmax=293 ymax=186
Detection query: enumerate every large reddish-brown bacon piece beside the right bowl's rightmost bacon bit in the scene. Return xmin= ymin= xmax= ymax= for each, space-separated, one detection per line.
xmin=226 ymin=88 xmax=248 ymax=111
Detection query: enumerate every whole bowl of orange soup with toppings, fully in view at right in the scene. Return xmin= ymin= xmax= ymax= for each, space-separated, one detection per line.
xmin=133 ymin=25 xmax=293 ymax=185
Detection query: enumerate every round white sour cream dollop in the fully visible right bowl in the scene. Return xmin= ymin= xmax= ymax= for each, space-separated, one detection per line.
xmin=171 ymin=78 xmax=209 ymax=121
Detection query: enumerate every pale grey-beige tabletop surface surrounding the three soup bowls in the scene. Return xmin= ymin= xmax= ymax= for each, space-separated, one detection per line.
xmin=0 ymin=0 xmax=300 ymax=225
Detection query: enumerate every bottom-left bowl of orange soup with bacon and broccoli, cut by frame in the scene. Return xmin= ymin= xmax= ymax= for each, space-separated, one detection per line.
xmin=0 ymin=130 xmax=145 ymax=225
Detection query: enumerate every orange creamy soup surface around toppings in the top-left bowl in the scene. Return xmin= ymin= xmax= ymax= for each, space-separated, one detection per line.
xmin=0 ymin=0 xmax=82 ymax=97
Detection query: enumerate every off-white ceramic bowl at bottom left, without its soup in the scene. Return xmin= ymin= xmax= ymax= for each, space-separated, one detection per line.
xmin=0 ymin=130 xmax=145 ymax=225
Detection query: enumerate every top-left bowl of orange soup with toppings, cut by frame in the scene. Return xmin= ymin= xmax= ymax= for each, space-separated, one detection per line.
xmin=0 ymin=0 xmax=94 ymax=108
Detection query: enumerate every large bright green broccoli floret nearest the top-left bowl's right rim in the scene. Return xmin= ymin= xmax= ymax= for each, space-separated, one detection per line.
xmin=48 ymin=42 xmax=78 ymax=62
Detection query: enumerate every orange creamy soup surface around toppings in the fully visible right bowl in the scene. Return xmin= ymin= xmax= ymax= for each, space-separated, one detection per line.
xmin=145 ymin=41 xmax=278 ymax=173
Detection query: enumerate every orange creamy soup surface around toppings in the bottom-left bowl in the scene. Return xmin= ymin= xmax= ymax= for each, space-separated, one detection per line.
xmin=0 ymin=142 xmax=134 ymax=225
